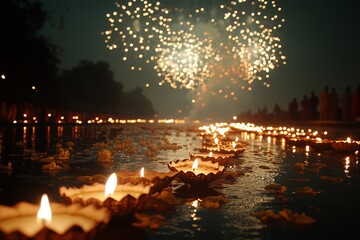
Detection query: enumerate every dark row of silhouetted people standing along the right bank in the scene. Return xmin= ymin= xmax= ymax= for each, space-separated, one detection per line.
xmin=238 ymin=85 xmax=360 ymax=123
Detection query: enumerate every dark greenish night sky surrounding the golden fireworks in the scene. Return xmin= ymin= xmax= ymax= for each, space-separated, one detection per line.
xmin=38 ymin=0 xmax=360 ymax=120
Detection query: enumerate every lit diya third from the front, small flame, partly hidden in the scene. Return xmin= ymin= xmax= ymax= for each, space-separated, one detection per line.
xmin=116 ymin=168 xmax=179 ymax=194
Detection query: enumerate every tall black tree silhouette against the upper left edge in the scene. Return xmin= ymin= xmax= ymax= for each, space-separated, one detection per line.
xmin=0 ymin=0 xmax=60 ymax=102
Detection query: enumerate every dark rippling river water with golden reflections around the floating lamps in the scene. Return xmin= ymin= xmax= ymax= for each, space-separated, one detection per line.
xmin=0 ymin=124 xmax=360 ymax=239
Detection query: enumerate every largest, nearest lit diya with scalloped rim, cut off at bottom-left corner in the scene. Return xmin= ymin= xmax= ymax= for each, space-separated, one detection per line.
xmin=0 ymin=194 xmax=110 ymax=240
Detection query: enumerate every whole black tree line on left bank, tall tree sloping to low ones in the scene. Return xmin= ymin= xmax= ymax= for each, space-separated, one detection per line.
xmin=0 ymin=0 xmax=156 ymax=121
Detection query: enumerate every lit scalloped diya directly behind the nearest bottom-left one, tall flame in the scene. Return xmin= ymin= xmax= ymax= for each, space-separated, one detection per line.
xmin=59 ymin=173 xmax=151 ymax=217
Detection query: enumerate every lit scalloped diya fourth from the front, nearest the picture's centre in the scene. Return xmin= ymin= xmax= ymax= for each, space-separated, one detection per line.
xmin=168 ymin=158 xmax=226 ymax=185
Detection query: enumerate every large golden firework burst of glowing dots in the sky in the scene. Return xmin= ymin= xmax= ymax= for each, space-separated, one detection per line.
xmin=103 ymin=0 xmax=286 ymax=100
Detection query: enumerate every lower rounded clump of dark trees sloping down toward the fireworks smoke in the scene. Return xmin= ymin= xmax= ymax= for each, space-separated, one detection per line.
xmin=54 ymin=60 xmax=155 ymax=117
